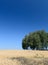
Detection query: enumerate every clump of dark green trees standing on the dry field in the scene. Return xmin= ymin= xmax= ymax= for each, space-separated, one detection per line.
xmin=22 ymin=30 xmax=48 ymax=50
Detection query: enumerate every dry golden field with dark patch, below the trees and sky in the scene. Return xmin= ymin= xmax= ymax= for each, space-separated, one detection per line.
xmin=0 ymin=50 xmax=48 ymax=65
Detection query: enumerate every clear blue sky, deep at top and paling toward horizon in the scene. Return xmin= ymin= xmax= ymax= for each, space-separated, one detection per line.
xmin=0 ymin=0 xmax=48 ymax=50
